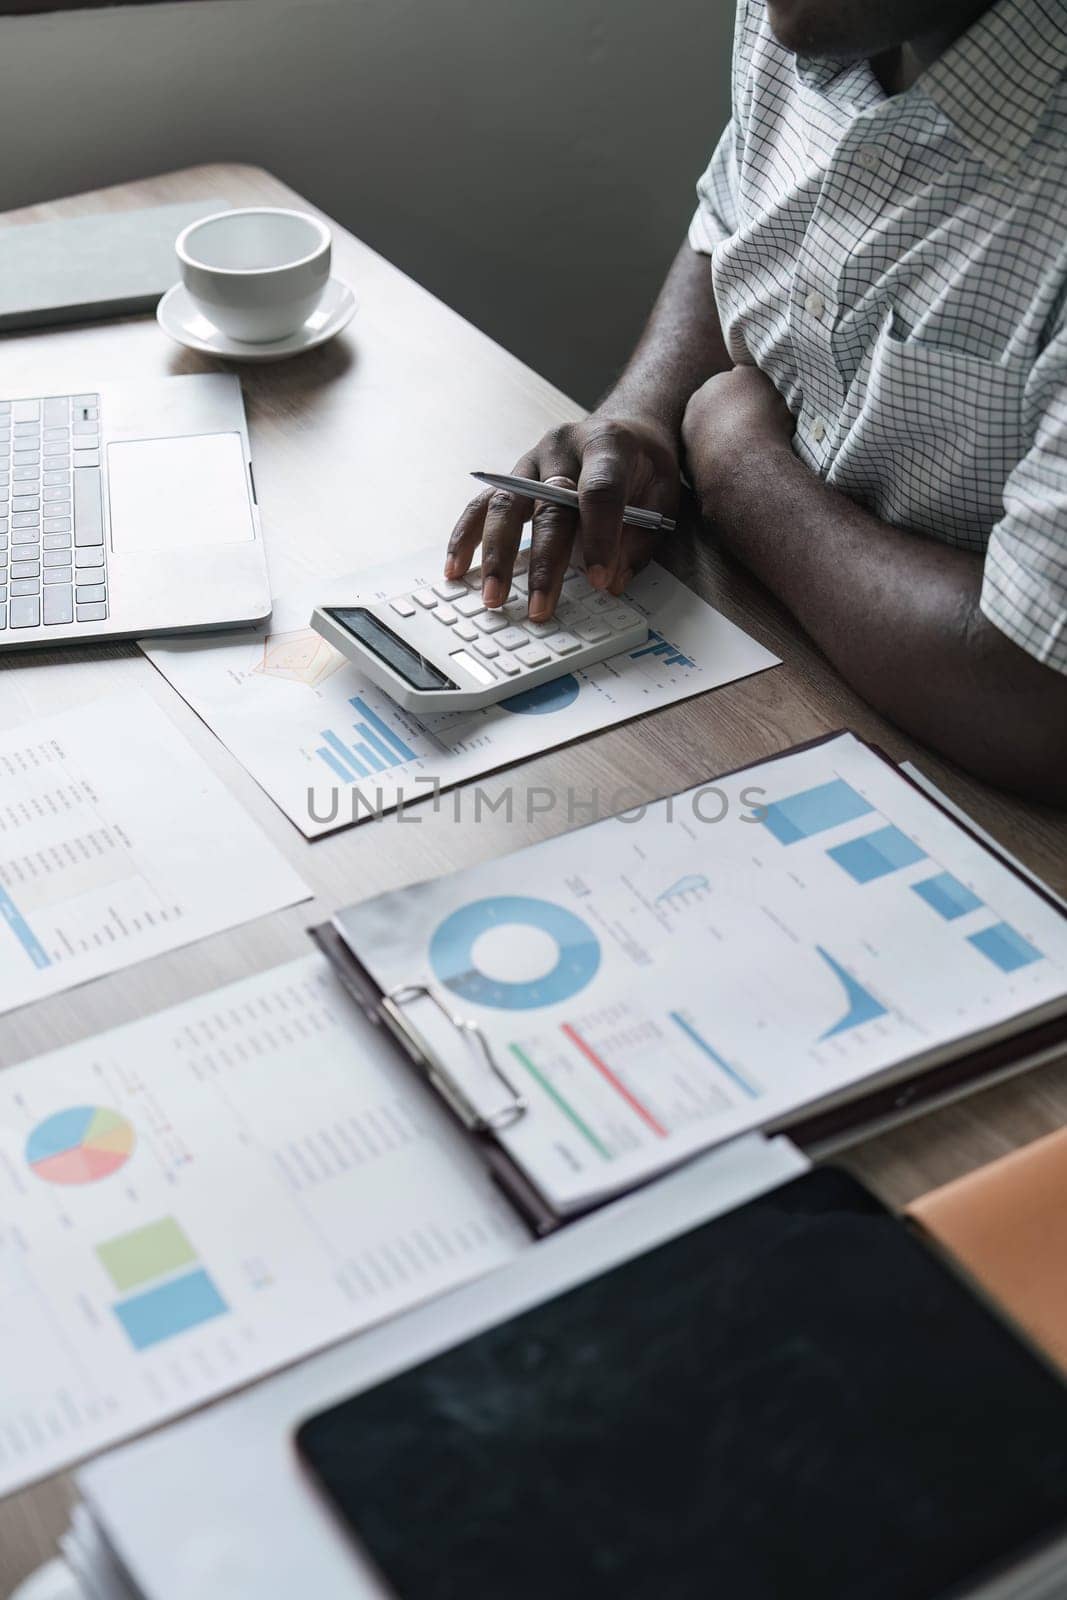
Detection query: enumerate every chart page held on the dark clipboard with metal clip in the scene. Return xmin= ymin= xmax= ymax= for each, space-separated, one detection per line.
xmin=334 ymin=734 xmax=1067 ymax=1214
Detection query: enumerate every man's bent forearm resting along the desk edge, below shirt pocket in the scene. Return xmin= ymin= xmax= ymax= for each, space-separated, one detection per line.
xmin=709 ymin=442 xmax=1067 ymax=803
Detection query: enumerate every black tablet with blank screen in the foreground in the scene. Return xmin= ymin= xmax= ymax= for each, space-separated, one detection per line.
xmin=298 ymin=1170 xmax=1067 ymax=1600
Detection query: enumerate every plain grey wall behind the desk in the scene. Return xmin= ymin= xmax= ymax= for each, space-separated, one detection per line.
xmin=0 ymin=0 xmax=733 ymax=402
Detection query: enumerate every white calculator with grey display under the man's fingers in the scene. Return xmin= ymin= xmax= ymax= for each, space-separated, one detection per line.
xmin=303 ymin=552 xmax=648 ymax=712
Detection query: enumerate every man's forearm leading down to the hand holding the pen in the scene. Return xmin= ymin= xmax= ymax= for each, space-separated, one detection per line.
xmin=601 ymin=243 xmax=731 ymax=437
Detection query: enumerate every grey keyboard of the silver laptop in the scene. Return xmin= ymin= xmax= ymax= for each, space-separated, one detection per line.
xmin=0 ymin=395 xmax=107 ymax=634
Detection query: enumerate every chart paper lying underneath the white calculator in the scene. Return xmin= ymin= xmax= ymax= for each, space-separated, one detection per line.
xmin=141 ymin=547 xmax=777 ymax=838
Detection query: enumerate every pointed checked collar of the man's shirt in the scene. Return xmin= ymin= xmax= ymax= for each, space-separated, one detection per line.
xmin=915 ymin=0 xmax=1067 ymax=171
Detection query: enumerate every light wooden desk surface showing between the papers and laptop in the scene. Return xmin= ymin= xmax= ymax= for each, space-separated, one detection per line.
xmin=0 ymin=166 xmax=1067 ymax=1595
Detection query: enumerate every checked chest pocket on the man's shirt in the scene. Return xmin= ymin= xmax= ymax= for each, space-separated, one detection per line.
xmin=827 ymin=318 xmax=1029 ymax=550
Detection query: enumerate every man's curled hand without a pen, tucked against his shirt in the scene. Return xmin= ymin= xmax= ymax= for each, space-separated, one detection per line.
xmin=681 ymin=366 xmax=795 ymax=520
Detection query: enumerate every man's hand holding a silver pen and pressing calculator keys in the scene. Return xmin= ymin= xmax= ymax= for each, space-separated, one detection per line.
xmin=445 ymin=410 xmax=680 ymax=622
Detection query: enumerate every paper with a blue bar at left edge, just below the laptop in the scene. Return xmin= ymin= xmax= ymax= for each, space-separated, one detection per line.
xmin=0 ymin=690 xmax=310 ymax=1011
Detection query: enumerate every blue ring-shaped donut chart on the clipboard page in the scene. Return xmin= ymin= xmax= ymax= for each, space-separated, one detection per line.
xmin=430 ymin=894 xmax=600 ymax=1011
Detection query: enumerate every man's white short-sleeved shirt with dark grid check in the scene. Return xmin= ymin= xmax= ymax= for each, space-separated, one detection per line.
xmin=689 ymin=0 xmax=1067 ymax=672
